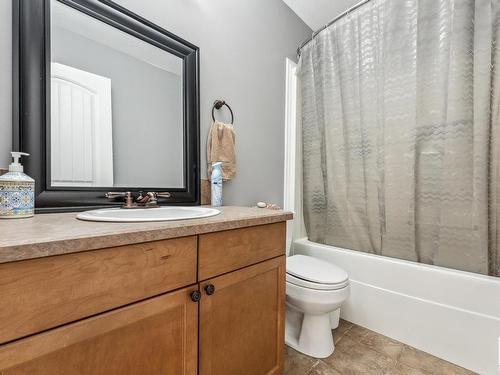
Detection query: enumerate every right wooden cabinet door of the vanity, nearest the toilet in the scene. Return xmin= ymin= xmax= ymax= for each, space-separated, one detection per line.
xmin=199 ymin=256 xmax=285 ymax=375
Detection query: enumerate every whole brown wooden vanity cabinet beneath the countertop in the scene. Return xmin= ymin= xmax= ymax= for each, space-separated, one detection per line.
xmin=0 ymin=222 xmax=285 ymax=375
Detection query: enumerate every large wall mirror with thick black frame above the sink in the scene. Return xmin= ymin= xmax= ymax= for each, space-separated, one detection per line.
xmin=13 ymin=0 xmax=199 ymax=212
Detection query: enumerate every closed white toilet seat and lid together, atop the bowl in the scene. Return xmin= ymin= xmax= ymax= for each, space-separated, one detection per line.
xmin=286 ymin=255 xmax=349 ymax=290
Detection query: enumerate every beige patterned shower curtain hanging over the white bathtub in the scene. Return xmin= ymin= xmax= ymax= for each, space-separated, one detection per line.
xmin=299 ymin=0 xmax=500 ymax=275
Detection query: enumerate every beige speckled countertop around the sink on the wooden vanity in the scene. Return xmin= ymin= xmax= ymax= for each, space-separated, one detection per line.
xmin=0 ymin=206 xmax=293 ymax=263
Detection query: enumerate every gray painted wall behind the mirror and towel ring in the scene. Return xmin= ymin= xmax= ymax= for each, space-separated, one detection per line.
xmin=0 ymin=0 xmax=311 ymax=205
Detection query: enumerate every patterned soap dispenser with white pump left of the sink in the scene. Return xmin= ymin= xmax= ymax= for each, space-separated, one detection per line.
xmin=0 ymin=151 xmax=35 ymax=219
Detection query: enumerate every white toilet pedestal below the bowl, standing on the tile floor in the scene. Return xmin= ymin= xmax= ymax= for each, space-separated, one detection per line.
xmin=285 ymin=304 xmax=339 ymax=358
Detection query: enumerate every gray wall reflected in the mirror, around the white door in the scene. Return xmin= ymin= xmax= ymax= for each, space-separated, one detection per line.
xmin=51 ymin=27 xmax=184 ymax=187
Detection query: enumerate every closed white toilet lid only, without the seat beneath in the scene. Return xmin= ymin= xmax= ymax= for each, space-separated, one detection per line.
xmin=286 ymin=255 xmax=349 ymax=284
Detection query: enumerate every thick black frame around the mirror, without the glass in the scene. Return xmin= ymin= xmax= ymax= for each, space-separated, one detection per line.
xmin=12 ymin=0 xmax=200 ymax=213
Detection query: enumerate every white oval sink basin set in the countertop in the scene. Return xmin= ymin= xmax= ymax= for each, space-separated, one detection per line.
xmin=76 ymin=207 xmax=220 ymax=223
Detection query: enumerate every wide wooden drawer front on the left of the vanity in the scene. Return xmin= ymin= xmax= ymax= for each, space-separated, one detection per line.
xmin=0 ymin=236 xmax=197 ymax=343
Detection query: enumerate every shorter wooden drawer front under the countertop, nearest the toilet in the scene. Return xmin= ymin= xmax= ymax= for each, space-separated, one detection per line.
xmin=198 ymin=222 xmax=286 ymax=280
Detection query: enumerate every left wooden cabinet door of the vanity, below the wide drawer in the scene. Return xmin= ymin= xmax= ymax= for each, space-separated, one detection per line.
xmin=0 ymin=287 xmax=198 ymax=375
